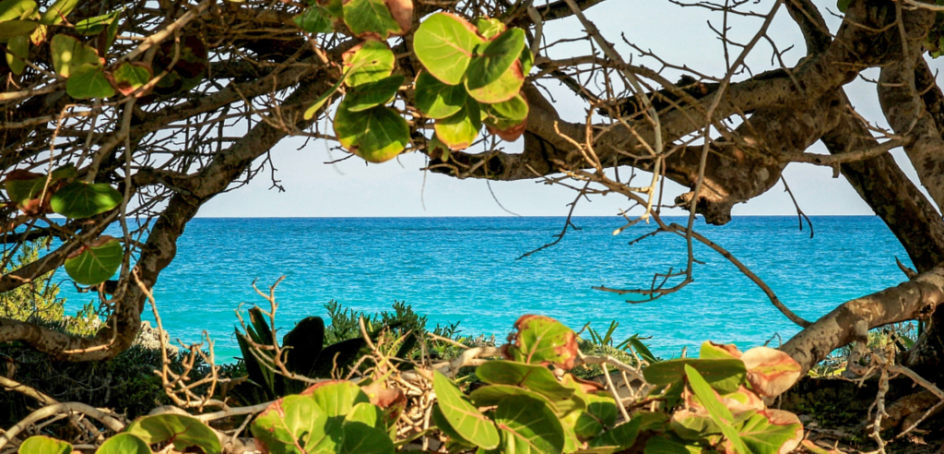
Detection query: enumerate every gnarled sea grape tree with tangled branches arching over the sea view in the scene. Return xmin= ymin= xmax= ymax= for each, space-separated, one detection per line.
xmin=0 ymin=0 xmax=944 ymax=394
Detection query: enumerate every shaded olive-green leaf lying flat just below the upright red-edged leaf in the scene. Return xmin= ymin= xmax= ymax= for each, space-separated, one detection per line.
xmin=475 ymin=361 xmax=574 ymax=404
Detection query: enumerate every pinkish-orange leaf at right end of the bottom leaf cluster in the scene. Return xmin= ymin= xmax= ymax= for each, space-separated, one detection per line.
xmin=741 ymin=347 xmax=802 ymax=397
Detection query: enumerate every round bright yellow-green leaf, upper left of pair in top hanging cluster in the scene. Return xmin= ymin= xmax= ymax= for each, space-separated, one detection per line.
xmin=413 ymin=13 xmax=485 ymax=85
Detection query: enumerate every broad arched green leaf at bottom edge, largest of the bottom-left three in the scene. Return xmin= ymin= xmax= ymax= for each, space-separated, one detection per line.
xmin=125 ymin=413 xmax=223 ymax=454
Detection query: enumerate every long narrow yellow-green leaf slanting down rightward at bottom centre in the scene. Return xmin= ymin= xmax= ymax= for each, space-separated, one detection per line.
xmin=433 ymin=372 xmax=500 ymax=449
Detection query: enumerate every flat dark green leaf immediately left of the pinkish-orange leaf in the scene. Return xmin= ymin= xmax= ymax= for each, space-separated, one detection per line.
xmin=642 ymin=358 xmax=747 ymax=394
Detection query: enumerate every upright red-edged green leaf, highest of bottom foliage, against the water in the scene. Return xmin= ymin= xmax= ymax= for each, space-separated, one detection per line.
xmin=502 ymin=315 xmax=577 ymax=370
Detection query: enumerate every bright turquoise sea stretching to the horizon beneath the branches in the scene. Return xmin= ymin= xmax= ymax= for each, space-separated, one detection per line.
xmin=62 ymin=217 xmax=908 ymax=359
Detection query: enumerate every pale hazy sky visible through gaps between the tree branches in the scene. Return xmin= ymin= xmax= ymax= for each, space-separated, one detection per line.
xmin=198 ymin=0 xmax=944 ymax=217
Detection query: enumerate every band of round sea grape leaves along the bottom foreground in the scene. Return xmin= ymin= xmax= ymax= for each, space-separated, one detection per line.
xmin=30 ymin=315 xmax=803 ymax=454
